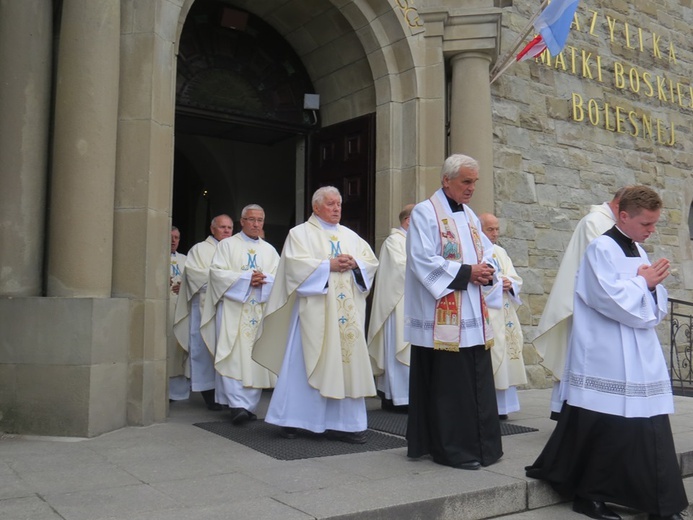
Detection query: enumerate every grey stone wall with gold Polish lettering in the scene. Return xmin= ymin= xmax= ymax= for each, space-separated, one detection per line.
xmin=491 ymin=0 xmax=693 ymax=387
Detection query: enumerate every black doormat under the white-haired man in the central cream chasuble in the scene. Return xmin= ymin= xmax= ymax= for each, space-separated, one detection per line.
xmin=195 ymin=421 xmax=407 ymax=460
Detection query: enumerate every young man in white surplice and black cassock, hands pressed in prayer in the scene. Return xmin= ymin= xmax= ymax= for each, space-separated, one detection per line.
xmin=526 ymin=186 xmax=688 ymax=520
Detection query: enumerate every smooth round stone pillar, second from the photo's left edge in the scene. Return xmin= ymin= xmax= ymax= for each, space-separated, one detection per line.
xmin=47 ymin=0 xmax=120 ymax=297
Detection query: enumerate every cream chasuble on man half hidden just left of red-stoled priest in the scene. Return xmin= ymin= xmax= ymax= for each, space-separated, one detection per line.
xmin=368 ymin=228 xmax=411 ymax=375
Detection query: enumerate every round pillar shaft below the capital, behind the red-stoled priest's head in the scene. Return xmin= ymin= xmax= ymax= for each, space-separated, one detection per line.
xmin=450 ymin=52 xmax=494 ymax=214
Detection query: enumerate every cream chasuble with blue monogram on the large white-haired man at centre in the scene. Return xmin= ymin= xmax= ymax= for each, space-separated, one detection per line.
xmin=253 ymin=215 xmax=378 ymax=399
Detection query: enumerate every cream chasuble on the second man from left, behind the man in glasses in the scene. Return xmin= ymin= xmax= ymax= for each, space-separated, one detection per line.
xmin=173 ymin=235 xmax=218 ymax=352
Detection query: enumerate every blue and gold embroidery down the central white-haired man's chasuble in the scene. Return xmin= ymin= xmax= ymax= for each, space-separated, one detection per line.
xmin=329 ymin=235 xmax=363 ymax=365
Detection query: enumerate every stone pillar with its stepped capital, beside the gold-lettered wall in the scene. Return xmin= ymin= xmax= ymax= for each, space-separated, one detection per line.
xmin=419 ymin=6 xmax=501 ymax=213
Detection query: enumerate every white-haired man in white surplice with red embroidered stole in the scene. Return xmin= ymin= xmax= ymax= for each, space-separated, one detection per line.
xmin=404 ymin=154 xmax=503 ymax=470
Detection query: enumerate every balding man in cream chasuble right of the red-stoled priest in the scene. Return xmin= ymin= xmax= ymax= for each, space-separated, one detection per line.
xmin=479 ymin=213 xmax=527 ymax=419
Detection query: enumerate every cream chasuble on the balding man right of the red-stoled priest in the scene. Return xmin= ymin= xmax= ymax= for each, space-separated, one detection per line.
xmin=484 ymin=245 xmax=527 ymax=390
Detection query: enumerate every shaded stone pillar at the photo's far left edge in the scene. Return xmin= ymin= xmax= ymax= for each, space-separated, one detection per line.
xmin=0 ymin=0 xmax=53 ymax=296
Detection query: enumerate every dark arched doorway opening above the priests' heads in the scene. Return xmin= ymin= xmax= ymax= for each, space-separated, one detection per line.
xmin=173 ymin=0 xmax=319 ymax=252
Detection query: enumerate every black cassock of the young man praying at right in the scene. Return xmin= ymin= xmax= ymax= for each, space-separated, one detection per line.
xmin=525 ymin=227 xmax=688 ymax=516
